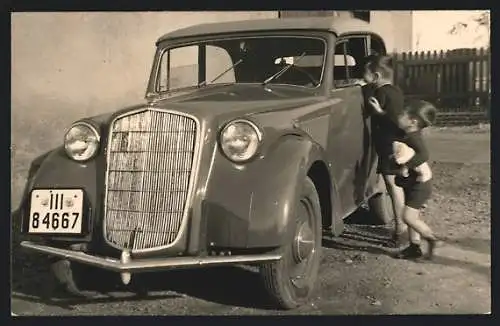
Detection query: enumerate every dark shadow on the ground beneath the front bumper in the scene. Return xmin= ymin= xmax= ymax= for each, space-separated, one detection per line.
xmin=12 ymin=267 xmax=273 ymax=310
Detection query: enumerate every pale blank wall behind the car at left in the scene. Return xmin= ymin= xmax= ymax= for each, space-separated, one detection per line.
xmin=11 ymin=11 xmax=278 ymax=114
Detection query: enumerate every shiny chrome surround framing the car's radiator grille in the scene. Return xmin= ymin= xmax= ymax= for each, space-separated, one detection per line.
xmin=102 ymin=106 xmax=205 ymax=254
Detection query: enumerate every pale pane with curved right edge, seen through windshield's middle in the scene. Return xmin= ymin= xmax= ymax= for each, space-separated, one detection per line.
xmin=205 ymin=45 xmax=236 ymax=83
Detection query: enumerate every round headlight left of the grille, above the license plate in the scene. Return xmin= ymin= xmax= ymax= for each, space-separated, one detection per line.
xmin=64 ymin=122 xmax=100 ymax=162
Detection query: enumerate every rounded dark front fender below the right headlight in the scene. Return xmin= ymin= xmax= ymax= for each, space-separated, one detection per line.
xmin=204 ymin=135 xmax=322 ymax=248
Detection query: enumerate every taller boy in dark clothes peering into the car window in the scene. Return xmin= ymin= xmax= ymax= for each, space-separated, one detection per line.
xmin=364 ymin=55 xmax=408 ymax=243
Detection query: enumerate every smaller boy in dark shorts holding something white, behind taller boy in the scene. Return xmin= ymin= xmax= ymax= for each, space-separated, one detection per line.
xmin=370 ymin=99 xmax=439 ymax=259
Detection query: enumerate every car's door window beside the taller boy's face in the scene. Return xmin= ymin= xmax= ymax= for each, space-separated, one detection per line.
xmin=333 ymin=36 xmax=368 ymax=87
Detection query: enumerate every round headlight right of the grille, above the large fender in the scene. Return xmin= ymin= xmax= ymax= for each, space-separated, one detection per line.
xmin=219 ymin=119 xmax=262 ymax=163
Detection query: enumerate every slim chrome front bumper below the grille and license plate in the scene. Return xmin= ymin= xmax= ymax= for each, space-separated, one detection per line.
xmin=21 ymin=241 xmax=282 ymax=273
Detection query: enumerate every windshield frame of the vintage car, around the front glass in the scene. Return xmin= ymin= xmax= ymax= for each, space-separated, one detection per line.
xmin=145 ymin=30 xmax=331 ymax=100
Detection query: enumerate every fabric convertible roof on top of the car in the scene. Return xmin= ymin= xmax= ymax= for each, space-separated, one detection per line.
xmin=157 ymin=17 xmax=373 ymax=43
